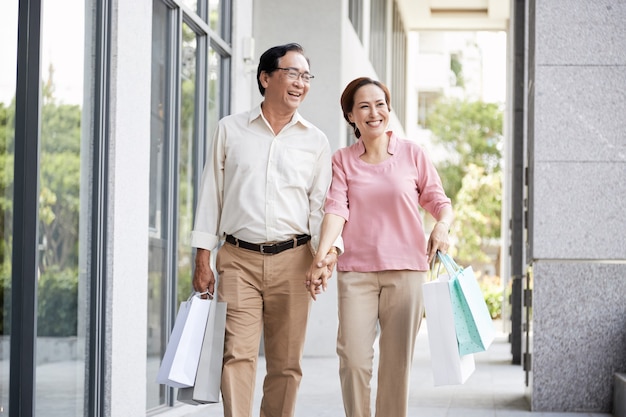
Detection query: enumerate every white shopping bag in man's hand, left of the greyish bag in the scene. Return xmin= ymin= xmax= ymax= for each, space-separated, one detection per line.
xmin=157 ymin=293 xmax=212 ymax=388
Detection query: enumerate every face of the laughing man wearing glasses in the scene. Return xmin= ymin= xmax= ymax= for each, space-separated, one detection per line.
xmin=261 ymin=51 xmax=309 ymax=111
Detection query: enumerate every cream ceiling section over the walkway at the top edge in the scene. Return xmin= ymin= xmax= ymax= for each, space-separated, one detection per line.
xmin=396 ymin=0 xmax=511 ymax=31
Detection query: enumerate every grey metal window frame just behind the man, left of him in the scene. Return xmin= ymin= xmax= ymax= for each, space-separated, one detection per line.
xmin=147 ymin=0 xmax=233 ymax=408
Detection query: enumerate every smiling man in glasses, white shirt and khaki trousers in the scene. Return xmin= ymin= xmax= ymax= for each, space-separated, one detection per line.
xmin=191 ymin=44 xmax=341 ymax=417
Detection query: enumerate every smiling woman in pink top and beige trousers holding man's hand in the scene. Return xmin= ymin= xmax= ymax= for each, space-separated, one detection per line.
xmin=307 ymin=77 xmax=453 ymax=417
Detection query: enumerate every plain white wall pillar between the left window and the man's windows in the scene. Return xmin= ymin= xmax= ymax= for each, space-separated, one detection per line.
xmin=107 ymin=0 xmax=152 ymax=417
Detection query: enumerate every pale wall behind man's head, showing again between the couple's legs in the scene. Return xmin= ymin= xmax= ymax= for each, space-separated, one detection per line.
xmin=253 ymin=0 xmax=347 ymax=356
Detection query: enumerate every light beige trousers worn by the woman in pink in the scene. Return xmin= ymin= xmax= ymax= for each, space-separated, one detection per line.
xmin=337 ymin=271 xmax=426 ymax=417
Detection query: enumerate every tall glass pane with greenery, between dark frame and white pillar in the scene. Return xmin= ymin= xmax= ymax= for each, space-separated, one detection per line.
xmin=35 ymin=0 xmax=91 ymax=417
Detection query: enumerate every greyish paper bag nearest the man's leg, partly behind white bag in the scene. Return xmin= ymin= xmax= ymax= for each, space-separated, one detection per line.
xmin=178 ymin=300 xmax=226 ymax=405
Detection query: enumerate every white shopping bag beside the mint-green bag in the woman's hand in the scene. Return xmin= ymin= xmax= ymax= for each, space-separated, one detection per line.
xmin=422 ymin=274 xmax=476 ymax=386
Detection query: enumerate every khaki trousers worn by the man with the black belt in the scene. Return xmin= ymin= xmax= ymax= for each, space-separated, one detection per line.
xmin=216 ymin=243 xmax=313 ymax=417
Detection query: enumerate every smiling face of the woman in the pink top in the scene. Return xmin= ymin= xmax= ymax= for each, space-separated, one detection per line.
xmin=348 ymin=84 xmax=389 ymax=138
